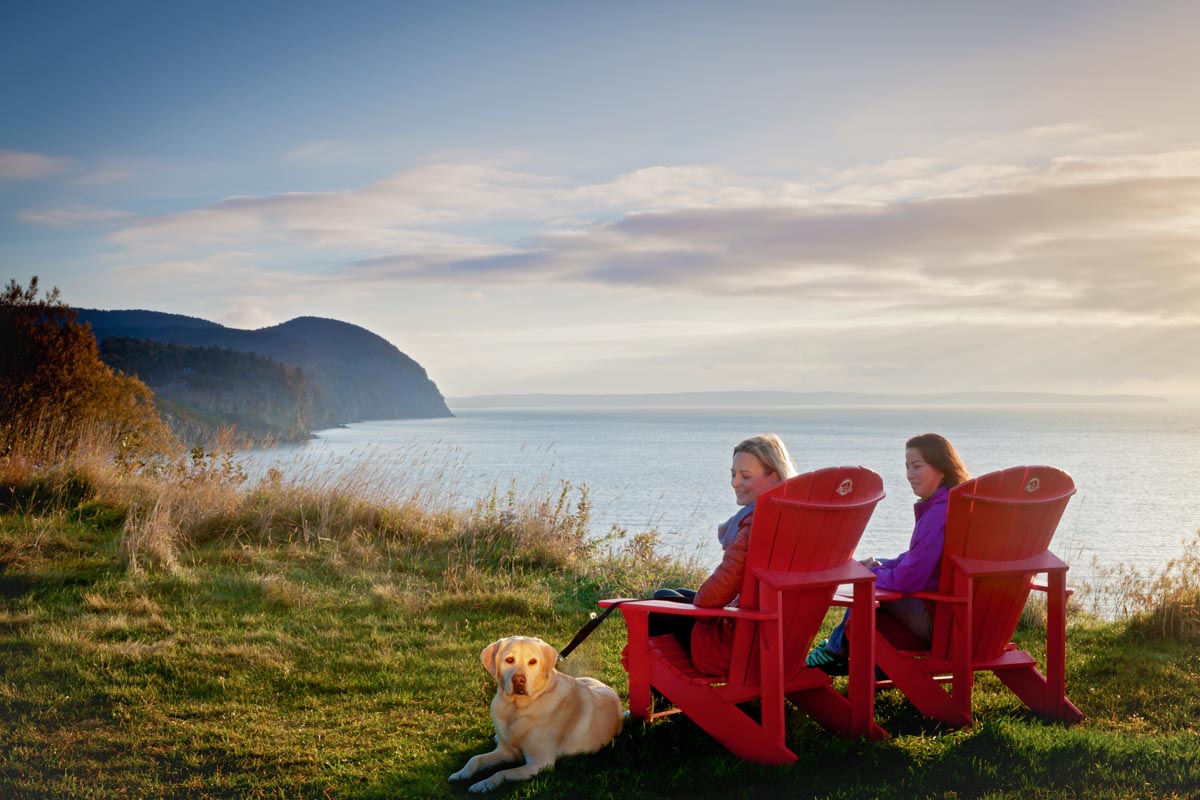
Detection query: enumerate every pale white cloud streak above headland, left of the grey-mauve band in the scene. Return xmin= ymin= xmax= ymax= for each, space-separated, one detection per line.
xmin=113 ymin=162 xmax=744 ymax=248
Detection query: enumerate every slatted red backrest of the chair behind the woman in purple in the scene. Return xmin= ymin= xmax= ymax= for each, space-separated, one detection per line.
xmin=932 ymin=467 xmax=1075 ymax=661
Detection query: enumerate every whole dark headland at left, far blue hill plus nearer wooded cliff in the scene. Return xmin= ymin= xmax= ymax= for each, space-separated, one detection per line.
xmin=77 ymin=308 xmax=452 ymax=440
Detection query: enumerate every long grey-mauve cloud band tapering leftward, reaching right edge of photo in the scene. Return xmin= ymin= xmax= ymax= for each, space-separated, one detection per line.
xmin=347 ymin=167 xmax=1200 ymax=321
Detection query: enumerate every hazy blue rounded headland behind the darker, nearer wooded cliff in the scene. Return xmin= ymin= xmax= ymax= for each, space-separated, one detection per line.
xmin=78 ymin=308 xmax=452 ymax=428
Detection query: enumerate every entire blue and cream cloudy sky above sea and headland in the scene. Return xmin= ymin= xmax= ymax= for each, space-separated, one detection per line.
xmin=0 ymin=0 xmax=1200 ymax=398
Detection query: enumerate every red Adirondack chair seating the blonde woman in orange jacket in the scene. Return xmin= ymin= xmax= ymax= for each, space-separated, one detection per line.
xmin=600 ymin=467 xmax=887 ymax=764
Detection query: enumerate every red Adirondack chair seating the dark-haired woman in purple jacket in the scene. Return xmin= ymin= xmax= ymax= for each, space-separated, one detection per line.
xmin=868 ymin=467 xmax=1084 ymax=726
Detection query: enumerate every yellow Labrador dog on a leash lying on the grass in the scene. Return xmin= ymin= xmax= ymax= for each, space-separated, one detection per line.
xmin=450 ymin=636 xmax=624 ymax=792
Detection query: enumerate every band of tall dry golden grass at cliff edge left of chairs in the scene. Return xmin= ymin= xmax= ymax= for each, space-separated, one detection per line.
xmin=0 ymin=417 xmax=698 ymax=594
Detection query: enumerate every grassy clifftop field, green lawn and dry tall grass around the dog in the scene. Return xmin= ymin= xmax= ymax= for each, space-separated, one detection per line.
xmin=0 ymin=455 xmax=1200 ymax=799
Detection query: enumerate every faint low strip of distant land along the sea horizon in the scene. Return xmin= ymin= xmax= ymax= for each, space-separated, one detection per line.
xmin=446 ymin=391 xmax=1166 ymax=409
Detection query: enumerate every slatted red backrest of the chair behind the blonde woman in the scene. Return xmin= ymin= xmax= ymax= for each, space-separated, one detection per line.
xmin=728 ymin=467 xmax=883 ymax=686
